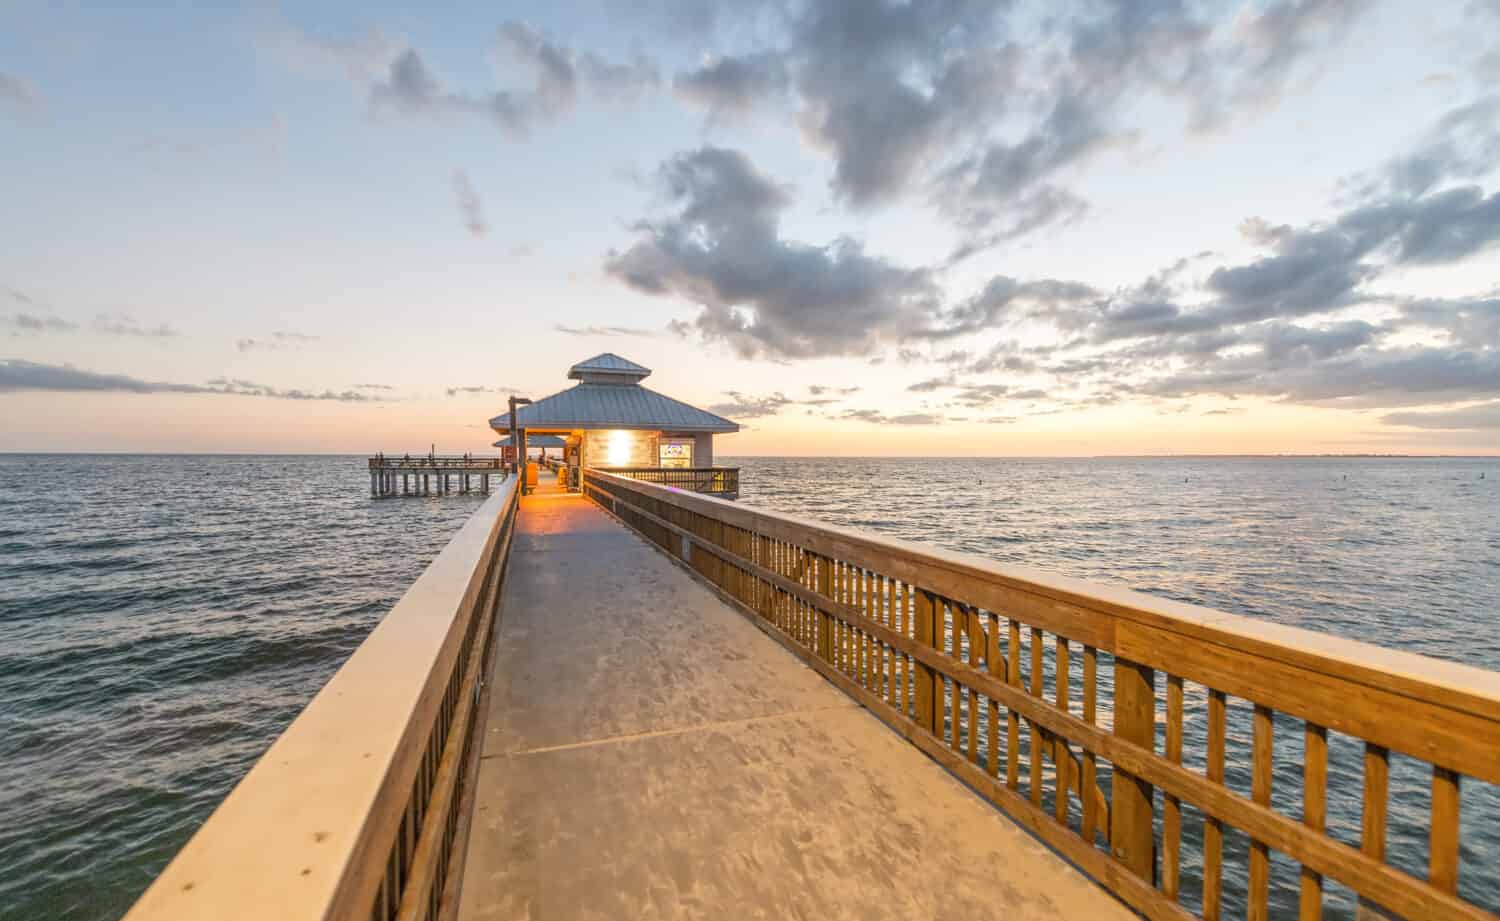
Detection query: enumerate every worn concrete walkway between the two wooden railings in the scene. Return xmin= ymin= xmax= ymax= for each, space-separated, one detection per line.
xmin=459 ymin=497 xmax=1136 ymax=921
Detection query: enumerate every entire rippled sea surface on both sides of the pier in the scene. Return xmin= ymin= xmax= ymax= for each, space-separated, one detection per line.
xmin=0 ymin=455 xmax=1500 ymax=921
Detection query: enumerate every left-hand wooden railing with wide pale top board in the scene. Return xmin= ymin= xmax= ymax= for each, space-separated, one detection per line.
xmin=126 ymin=477 xmax=519 ymax=921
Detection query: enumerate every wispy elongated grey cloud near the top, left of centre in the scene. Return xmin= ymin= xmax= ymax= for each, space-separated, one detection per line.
xmin=369 ymin=21 xmax=660 ymax=138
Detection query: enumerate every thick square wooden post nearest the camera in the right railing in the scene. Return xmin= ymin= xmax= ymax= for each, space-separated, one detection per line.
xmin=1110 ymin=657 xmax=1157 ymax=882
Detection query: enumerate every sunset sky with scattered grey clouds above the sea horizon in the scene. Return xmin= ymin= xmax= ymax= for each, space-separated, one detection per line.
xmin=0 ymin=0 xmax=1500 ymax=456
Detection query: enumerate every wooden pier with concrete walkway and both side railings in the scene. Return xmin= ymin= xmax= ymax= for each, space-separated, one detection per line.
xmin=128 ymin=470 xmax=1500 ymax=921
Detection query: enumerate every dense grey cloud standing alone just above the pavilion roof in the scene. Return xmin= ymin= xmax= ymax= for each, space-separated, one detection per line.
xmin=605 ymin=147 xmax=938 ymax=359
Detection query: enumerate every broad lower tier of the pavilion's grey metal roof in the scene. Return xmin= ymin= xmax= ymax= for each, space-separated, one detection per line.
xmin=489 ymin=387 xmax=740 ymax=432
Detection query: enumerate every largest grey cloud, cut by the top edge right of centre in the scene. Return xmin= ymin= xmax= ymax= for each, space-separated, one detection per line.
xmin=657 ymin=0 xmax=1370 ymax=261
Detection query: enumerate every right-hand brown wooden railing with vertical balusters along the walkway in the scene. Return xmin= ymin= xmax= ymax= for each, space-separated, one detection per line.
xmin=585 ymin=471 xmax=1500 ymax=921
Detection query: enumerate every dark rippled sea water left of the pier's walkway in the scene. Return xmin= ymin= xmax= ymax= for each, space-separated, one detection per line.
xmin=0 ymin=455 xmax=482 ymax=921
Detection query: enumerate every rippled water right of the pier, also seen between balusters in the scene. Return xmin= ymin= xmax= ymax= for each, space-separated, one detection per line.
xmin=723 ymin=458 xmax=1500 ymax=918
